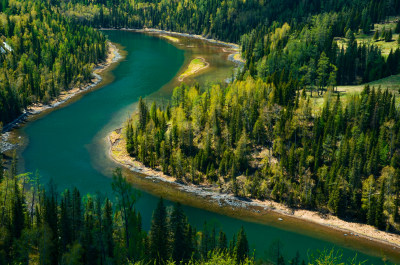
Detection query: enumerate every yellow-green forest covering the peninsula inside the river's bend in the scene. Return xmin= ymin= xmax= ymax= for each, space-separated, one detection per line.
xmin=126 ymin=76 xmax=400 ymax=230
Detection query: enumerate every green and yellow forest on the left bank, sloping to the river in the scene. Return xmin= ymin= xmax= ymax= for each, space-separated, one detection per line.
xmin=0 ymin=0 xmax=107 ymax=123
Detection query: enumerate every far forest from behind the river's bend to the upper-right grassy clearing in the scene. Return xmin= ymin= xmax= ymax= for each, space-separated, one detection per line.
xmin=57 ymin=0 xmax=400 ymax=87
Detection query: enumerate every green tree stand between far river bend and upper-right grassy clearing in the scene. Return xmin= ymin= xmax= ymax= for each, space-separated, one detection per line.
xmin=239 ymin=11 xmax=400 ymax=88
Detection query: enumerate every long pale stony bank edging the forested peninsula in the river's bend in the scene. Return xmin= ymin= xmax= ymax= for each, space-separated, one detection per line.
xmin=108 ymin=129 xmax=400 ymax=250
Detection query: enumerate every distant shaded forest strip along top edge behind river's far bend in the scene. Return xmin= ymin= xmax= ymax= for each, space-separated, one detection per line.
xmin=56 ymin=0 xmax=400 ymax=42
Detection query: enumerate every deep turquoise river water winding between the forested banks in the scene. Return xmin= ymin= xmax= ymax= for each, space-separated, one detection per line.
xmin=21 ymin=31 xmax=394 ymax=264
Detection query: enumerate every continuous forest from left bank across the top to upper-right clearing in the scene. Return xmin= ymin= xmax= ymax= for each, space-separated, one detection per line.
xmin=0 ymin=0 xmax=400 ymax=123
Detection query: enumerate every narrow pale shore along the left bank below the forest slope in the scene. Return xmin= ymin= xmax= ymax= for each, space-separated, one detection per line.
xmin=0 ymin=42 xmax=122 ymax=134
